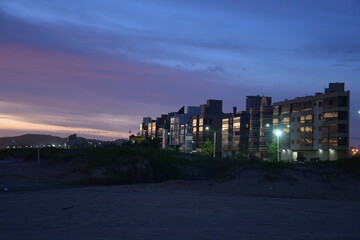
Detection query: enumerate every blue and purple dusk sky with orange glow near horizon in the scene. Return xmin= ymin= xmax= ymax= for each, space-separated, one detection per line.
xmin=0 ymin=0 xmax=360 ymax=145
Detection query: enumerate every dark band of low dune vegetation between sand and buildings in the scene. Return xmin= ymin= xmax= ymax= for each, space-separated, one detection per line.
xmin=0 ymin=145 xmax=360 ymax=184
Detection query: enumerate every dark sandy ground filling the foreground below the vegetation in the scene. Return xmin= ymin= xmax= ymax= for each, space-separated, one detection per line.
xmin=0 ymin=158 xmax=360 ymax=240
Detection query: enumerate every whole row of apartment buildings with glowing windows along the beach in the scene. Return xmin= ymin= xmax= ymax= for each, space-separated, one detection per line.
xmin=138 ymin=83 xmax=350 ymax=161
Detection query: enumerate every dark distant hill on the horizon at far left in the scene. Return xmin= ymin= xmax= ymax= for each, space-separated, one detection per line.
xmin=0 ymin=134 xmax=66 ymax=148
